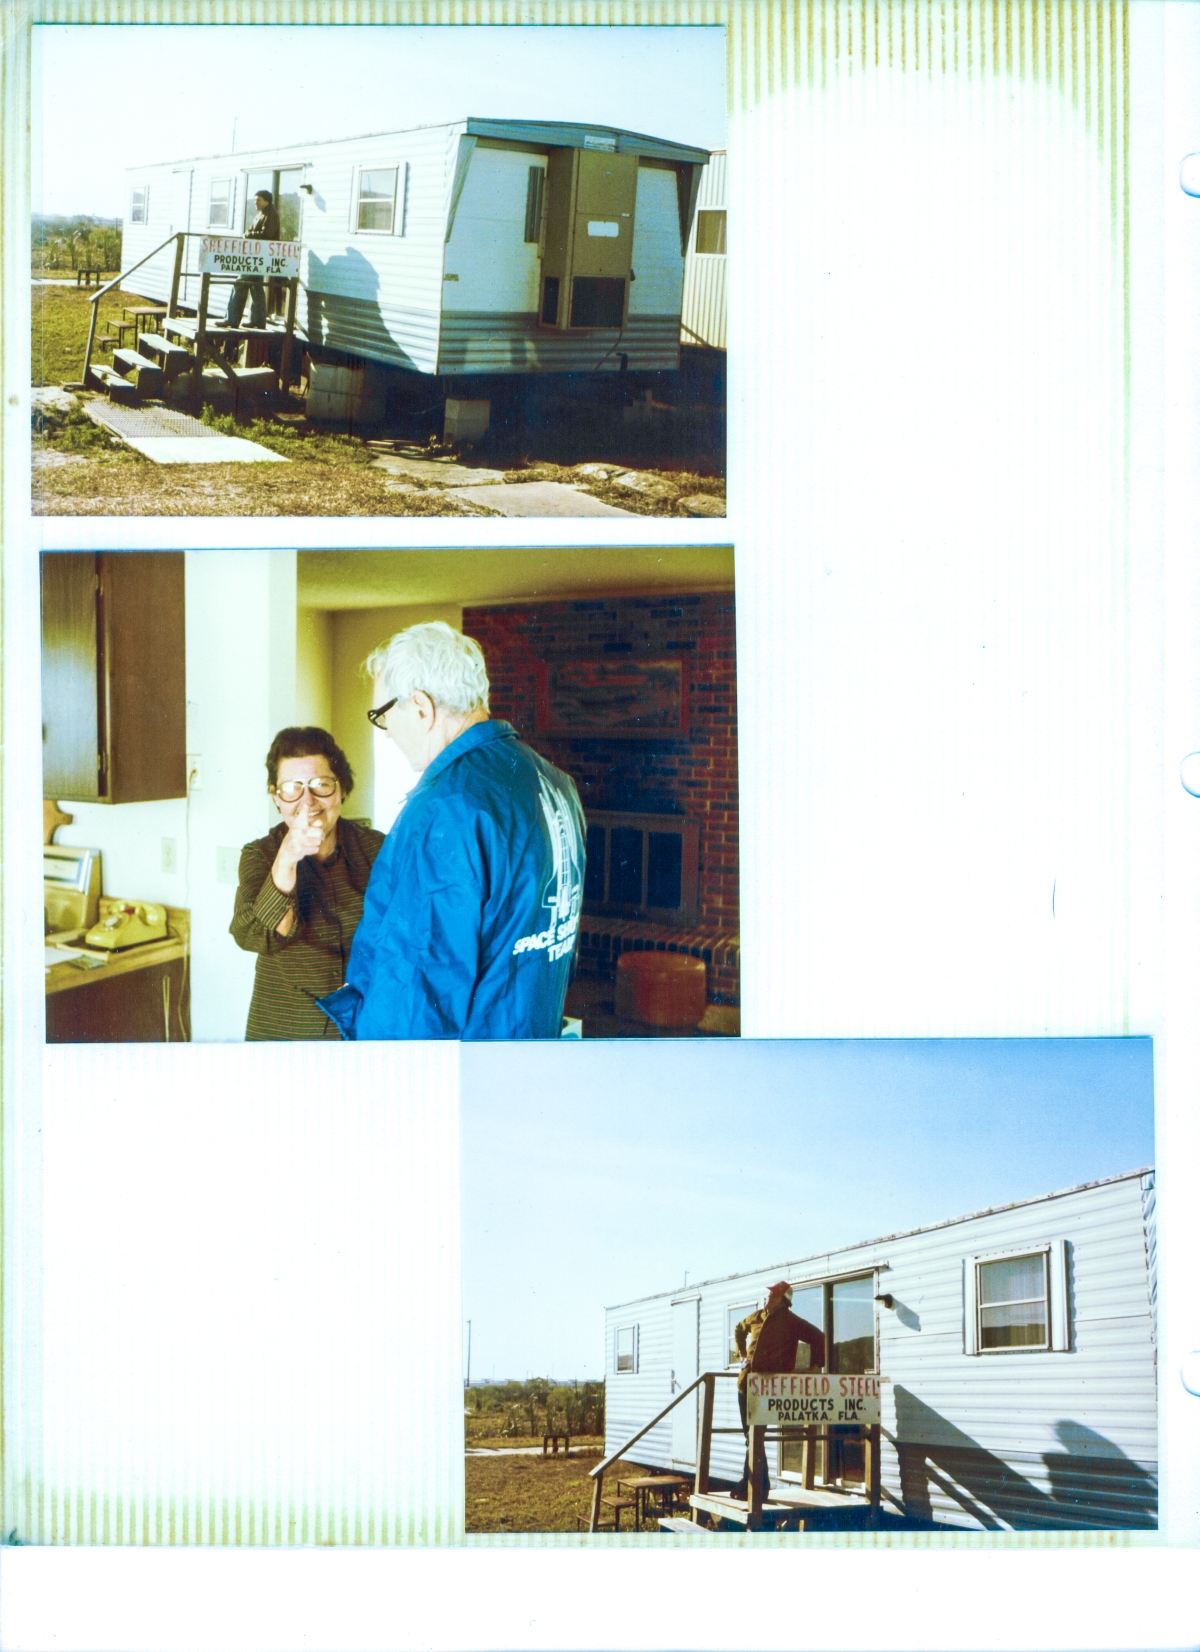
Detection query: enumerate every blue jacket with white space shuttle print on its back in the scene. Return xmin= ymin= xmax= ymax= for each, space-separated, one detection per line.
xmin=317 ymin=722 xmax=585 ymax=1039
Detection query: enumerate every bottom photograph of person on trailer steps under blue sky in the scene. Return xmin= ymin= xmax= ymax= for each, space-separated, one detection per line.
xmin=461 ymin=1039 xmax=1157 ymax=1543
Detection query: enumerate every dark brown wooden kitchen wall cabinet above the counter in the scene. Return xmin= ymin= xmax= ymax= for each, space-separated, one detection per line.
xmin=41 ymin=550 xmax=187 ymax=803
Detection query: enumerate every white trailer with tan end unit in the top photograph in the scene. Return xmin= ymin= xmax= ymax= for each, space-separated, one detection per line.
xmin=122 ymin=119 xmax=709 ymax=375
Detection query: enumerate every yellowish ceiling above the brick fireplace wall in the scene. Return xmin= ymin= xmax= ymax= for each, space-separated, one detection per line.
xmin=296 ymin=545 xmax=734 ymax=610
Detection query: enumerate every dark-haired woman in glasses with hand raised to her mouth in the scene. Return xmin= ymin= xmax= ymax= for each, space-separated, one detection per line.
xmin=230 ymin=729 xmax=383 ymax=1039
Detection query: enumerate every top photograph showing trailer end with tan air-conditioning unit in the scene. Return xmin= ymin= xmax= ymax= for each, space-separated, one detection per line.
xmin=31 ymin=25 xmax=726 ymax=520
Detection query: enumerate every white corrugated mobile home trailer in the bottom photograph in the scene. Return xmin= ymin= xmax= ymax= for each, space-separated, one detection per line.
xmin=605 ymin=1170 xmax=1157 ymax=1530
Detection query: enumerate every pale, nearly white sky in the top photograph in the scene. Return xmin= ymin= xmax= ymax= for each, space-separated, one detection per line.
xmin=33 ymin=23 xmax=726 ymax=218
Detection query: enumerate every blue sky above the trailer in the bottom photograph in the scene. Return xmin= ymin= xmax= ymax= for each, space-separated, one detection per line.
xmin=463 ymin=1039 xmax=1154 ymax=1379
